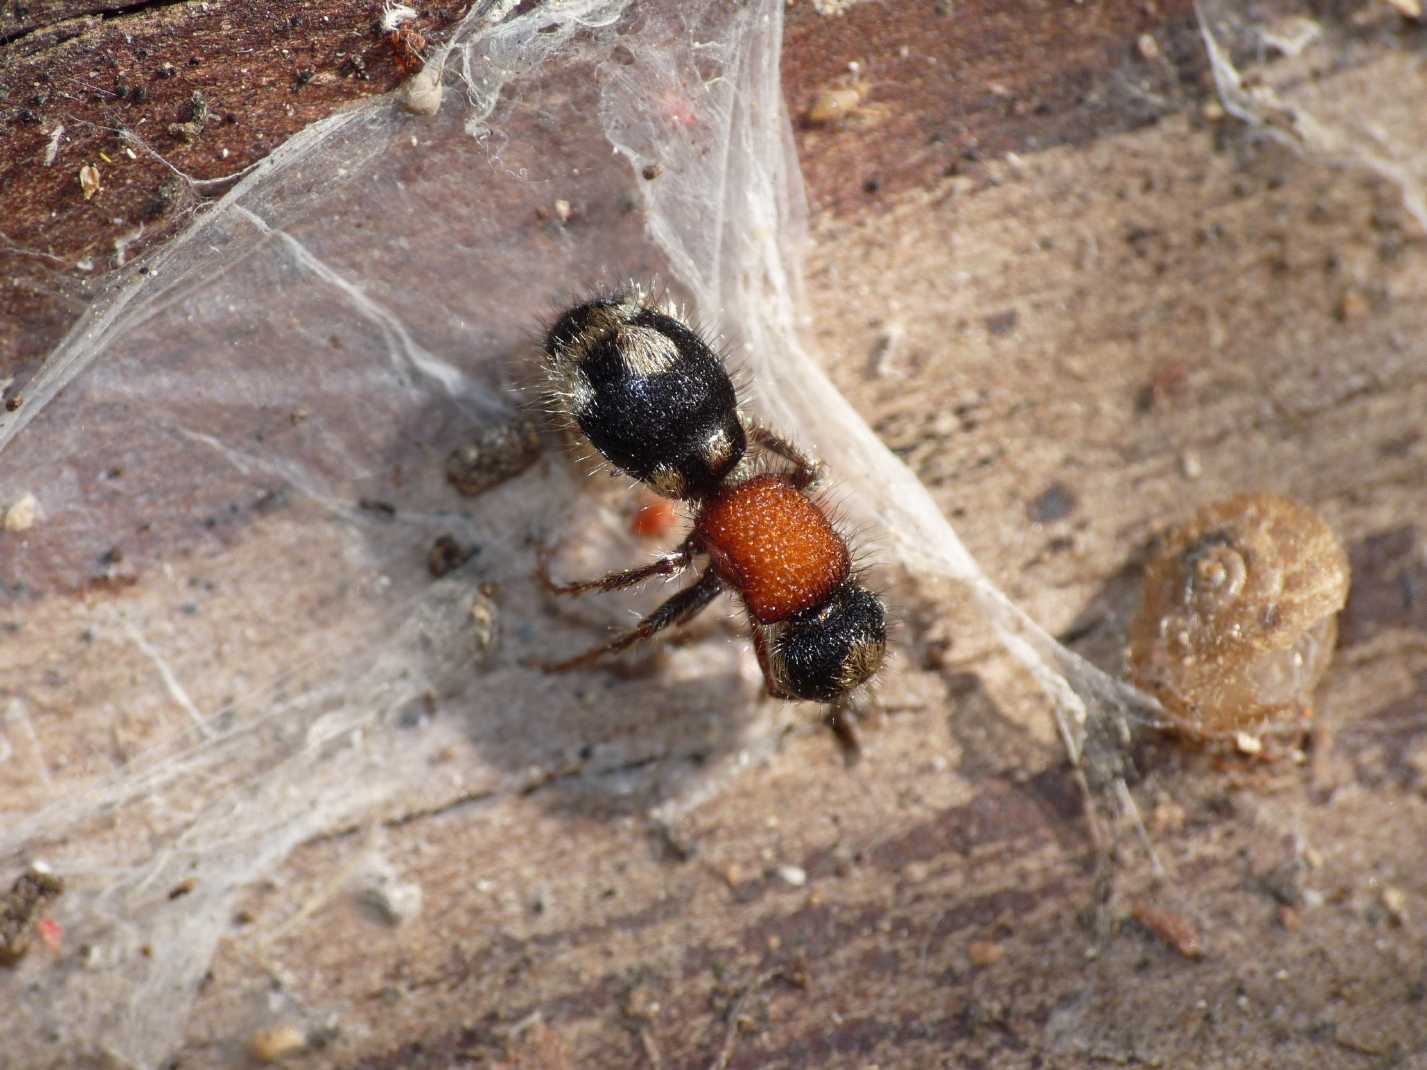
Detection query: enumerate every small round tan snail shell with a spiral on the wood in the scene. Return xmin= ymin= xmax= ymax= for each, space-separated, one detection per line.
xmin=1129 ymin=494 xmax=1349 ymax=739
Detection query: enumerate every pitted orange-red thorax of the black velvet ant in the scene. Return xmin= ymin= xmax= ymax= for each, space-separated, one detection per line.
xmin=695 ymin=475 xmax=852 ymax=623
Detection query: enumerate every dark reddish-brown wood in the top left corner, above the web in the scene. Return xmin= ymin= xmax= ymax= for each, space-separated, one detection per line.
xmin=0 ymin=1 xmax=464 ymax=382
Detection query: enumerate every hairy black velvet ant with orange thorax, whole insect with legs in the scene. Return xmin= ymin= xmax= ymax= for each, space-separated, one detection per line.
xmin=541 ymin=288 xmax=886 ymax=748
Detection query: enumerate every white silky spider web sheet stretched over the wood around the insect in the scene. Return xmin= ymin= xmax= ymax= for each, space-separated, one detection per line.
xmin=0 ymin=0 xmax=1404 ymax=1066
